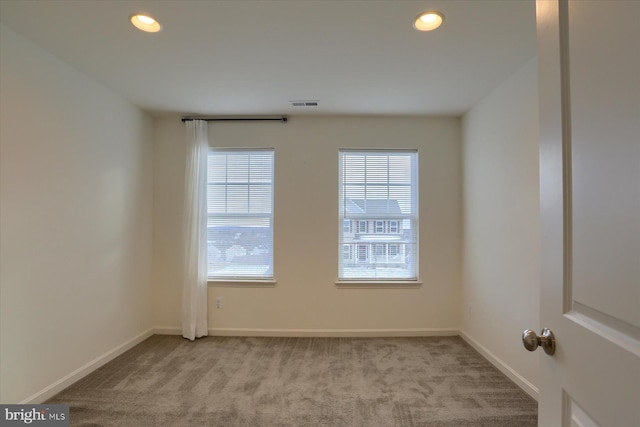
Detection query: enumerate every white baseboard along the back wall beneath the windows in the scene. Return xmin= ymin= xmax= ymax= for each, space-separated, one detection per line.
xmin=154 ymin=326 xmax=458 ymax=337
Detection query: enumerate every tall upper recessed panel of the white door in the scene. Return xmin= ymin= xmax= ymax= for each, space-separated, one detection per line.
xmin=568 ymin=1 xmax=640 ymax=328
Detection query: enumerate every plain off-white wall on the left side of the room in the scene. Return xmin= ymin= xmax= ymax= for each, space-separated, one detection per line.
xmin=0 ymin=27 xmax=153 ymax=403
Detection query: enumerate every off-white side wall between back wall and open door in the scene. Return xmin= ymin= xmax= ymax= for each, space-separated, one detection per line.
xmin=461 ymin=59 xmax=540 ymax=395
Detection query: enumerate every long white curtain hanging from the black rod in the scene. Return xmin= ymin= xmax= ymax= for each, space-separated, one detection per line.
xmin=182 ymin=120 xmax=209 ymax=341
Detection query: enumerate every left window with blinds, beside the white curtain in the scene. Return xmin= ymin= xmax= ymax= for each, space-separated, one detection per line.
xmin=207 ymin=149 xmax=274 ymax=280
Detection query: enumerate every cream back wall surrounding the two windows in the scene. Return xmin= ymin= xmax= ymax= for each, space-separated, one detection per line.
xmin=153 ymin=116 xmax=462 ymax=335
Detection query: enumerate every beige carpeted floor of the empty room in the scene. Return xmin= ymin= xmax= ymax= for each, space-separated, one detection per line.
xmin=49 ymin=335 xmax=537 ymax=427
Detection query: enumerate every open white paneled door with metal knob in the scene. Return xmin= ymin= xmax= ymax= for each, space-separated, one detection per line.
xmin=537 ymin=0 xmax=640 ymax=427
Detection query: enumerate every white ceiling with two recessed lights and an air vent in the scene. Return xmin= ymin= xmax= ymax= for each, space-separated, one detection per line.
xmin=0 ymin=0 xmax=536 ymax=115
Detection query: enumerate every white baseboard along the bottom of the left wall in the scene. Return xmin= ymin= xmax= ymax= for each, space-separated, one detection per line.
xmin=19 ymin=329 xmax=153 ymax=405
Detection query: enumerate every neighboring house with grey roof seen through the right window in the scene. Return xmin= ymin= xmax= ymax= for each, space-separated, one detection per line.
xmin=342 ymin=199 xmax=411 ymax=267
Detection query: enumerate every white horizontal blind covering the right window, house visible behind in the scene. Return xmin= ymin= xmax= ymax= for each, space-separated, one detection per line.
xmin=338 ymin=150 xmax=418 ymax=281
